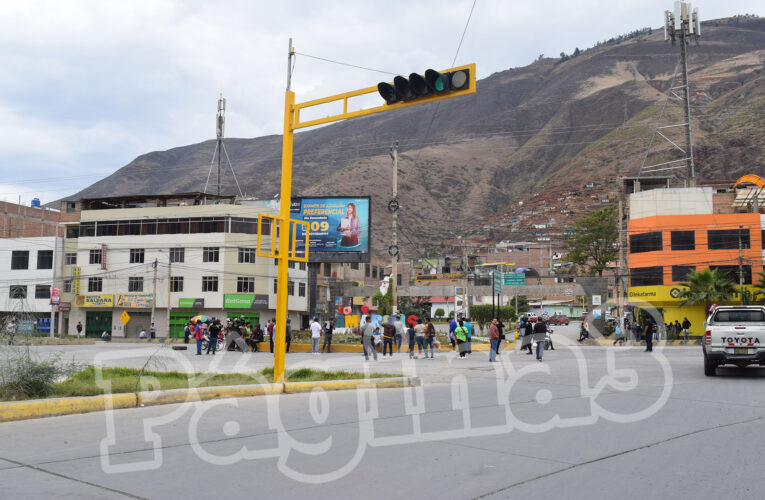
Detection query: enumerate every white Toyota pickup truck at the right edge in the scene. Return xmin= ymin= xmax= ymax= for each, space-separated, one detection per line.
xmin=702 ymin=306 xmax=765 ymax=377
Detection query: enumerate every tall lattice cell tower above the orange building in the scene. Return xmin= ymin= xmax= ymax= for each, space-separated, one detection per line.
xmin=638 ymin=2 xmax=701 ymax=186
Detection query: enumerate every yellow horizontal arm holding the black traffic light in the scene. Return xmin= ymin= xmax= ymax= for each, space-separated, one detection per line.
xmin=292 ymin=63 xmax=476 ymax=130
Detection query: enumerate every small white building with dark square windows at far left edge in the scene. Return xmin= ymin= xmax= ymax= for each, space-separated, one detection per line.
xmin=0 ymin=236 xmax=61 ymax=332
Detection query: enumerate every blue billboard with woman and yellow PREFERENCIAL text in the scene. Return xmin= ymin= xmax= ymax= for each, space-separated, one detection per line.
xmin=290 ymin=196 xmax=370 ymax=262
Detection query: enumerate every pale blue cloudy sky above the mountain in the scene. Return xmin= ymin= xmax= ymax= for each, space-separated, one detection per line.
xmin=0 ymin=0 xmax=765 ymax=205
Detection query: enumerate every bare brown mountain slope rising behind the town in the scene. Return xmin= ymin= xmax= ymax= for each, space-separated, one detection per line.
xmin=72 ymin=16 xmax=765 ymax=256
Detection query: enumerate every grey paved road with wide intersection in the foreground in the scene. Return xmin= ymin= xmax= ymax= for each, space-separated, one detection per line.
xmin=0 ymin=335 xmax=765 ymax=500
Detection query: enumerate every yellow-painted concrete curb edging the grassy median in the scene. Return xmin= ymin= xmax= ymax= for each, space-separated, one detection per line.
xmin=0 ymin=377 xmax=422 ymax=422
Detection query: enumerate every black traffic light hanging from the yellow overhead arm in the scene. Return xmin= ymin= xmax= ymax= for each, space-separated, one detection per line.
xmin=377 ymin=68 xmax=470 ymax=105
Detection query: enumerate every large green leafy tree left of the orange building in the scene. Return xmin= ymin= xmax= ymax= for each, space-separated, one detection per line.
xmin=564 ymin=207 xmax=619 ymax=278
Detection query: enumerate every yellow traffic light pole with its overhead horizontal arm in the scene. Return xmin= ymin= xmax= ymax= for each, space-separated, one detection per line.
xmin=268 ymin=39 xmax=476 ymax=383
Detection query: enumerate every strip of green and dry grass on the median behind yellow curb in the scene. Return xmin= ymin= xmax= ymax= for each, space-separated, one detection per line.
xmin=0 ymin=366 xmax=401 ymax=401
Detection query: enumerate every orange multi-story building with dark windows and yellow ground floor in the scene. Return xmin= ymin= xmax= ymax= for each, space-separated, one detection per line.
xmin=627 ymin=186 xmax=765 ymax=335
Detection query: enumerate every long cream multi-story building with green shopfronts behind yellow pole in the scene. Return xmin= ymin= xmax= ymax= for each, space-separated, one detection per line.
xmin=62 ymin=193 xmax=308 ymax=338
